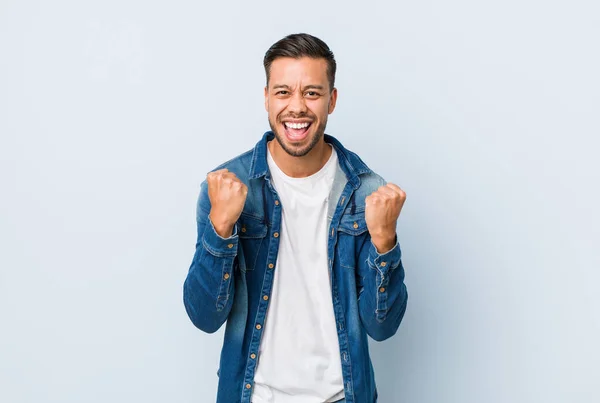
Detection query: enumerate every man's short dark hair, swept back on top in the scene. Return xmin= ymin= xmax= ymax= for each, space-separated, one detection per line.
xmin=263 ymin=34 xmax=336 ymax=90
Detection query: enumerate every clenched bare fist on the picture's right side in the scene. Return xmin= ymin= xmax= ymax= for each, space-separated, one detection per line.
xmin=365 ymin=183 xmax=406 ymax=253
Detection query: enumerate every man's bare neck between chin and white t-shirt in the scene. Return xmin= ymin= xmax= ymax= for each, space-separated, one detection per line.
xmin=267 ymin=139 xmax=332 ymax=178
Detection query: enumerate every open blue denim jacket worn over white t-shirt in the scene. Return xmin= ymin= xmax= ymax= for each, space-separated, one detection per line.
xmin=183 ymin=132 xmax=408 ymax=403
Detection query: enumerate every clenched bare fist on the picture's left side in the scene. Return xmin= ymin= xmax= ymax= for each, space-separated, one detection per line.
xmin=206 ymin=168 xmax=248 ymax=238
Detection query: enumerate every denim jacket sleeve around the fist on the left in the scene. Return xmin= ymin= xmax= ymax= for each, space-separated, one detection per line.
xmin=183 ymin=181 xmax=239 ymax=333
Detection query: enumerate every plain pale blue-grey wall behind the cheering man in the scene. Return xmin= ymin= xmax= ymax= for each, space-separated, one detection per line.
xmin=0 ymin=0 xmax=600 ymax=403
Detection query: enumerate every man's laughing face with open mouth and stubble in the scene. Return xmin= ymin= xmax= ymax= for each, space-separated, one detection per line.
xmin=265 ymin=57 xmax=337 ymax=157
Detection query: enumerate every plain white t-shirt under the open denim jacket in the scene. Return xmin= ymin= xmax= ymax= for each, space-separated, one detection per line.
xmin=252 ymin=144 xmax=344 ymax=403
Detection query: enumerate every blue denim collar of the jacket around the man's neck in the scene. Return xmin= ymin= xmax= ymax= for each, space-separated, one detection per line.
xmin=249 ymin=131 xmax=371 ymax=189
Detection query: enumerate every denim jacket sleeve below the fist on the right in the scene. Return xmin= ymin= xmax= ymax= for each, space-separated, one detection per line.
xmin=357 ymin=233 xmax=408 ymax=341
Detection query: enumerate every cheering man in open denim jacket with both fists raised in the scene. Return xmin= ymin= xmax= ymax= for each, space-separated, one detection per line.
xmin=183 ymin=34 xmax=408 ymax=403
